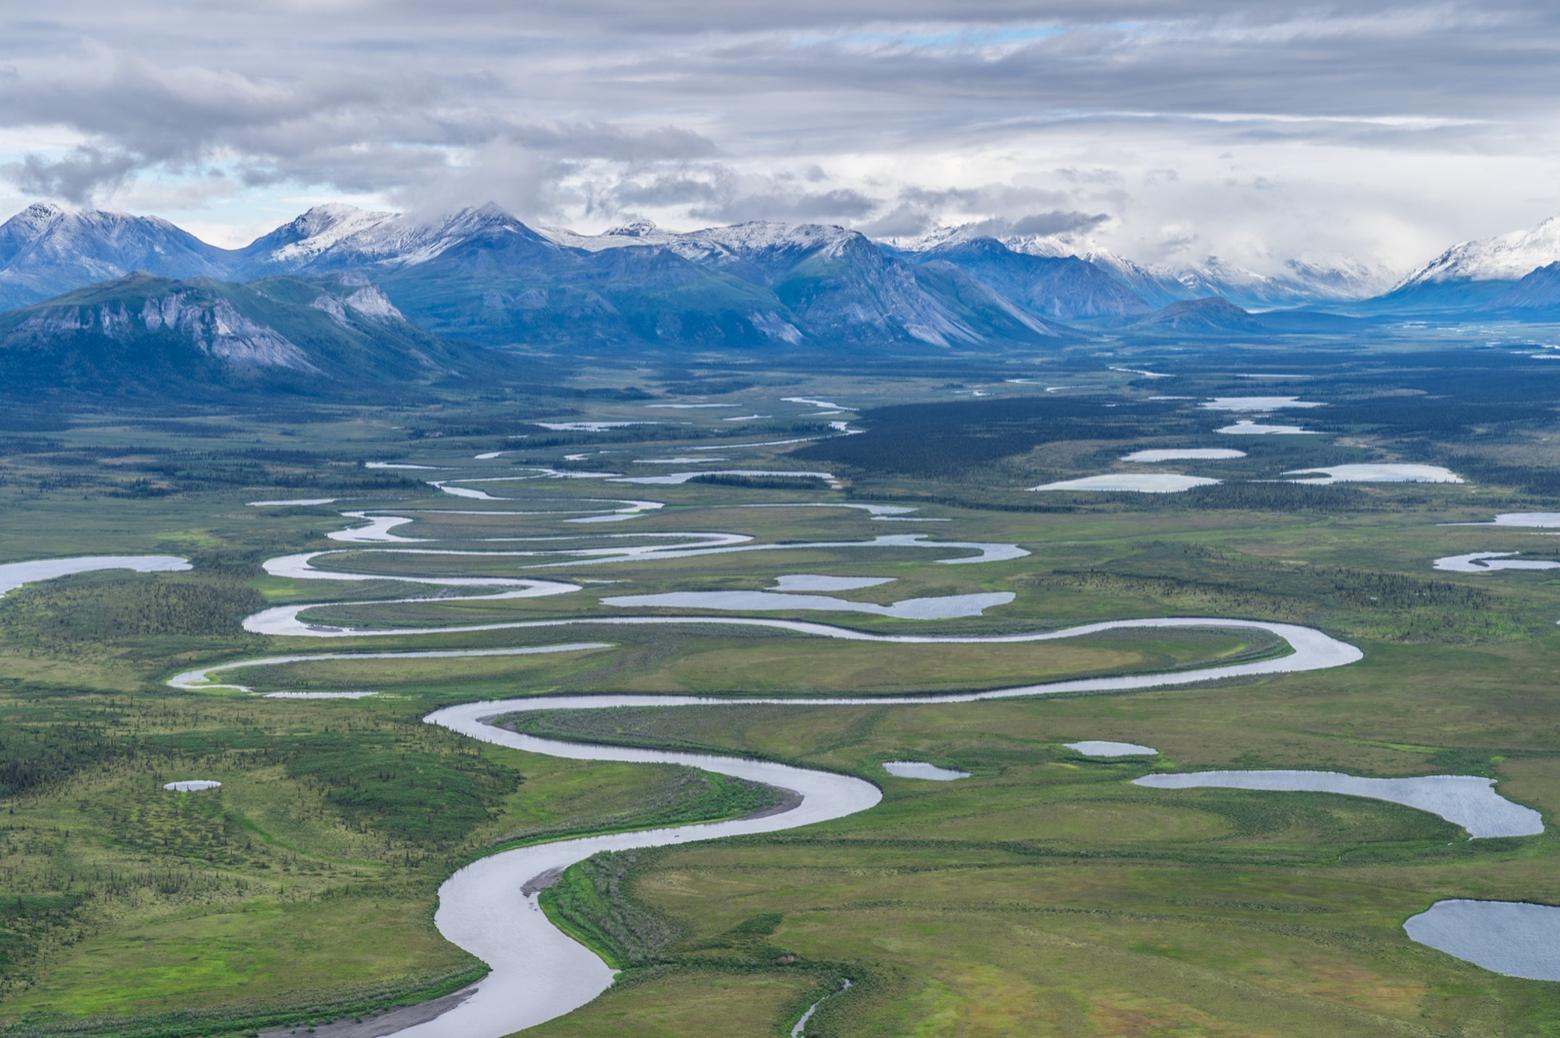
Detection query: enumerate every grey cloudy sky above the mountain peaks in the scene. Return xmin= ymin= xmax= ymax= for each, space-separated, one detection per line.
xmin=0 ymin=0 xmax=1560 ymax=270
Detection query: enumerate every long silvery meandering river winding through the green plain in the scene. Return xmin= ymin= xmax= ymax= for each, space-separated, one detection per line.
xmin=168 ymin=503 xmax=1360 ymax=1038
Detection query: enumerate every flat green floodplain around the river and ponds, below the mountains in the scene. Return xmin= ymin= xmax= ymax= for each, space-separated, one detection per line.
xmin=9 ymin=349 xmax=1560 ymax=1036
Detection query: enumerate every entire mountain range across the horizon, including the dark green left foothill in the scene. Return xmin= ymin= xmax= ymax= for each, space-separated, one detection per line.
xmin=0 ymin=203 xmax=1560 ymax=382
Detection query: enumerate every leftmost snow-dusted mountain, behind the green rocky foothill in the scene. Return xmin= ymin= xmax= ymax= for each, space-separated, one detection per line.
xmin=0 ymin=203 xmax=228 ymax=309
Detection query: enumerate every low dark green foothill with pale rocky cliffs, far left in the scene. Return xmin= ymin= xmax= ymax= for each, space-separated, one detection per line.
xmin=0 ymin=275 xmax=498 ymax=395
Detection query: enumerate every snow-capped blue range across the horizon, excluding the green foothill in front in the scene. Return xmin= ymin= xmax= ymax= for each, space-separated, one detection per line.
xmin=18 ymin=197 xmax=1541 ymax=350
